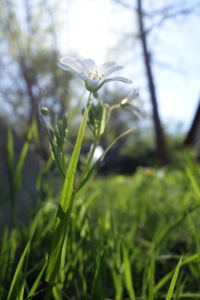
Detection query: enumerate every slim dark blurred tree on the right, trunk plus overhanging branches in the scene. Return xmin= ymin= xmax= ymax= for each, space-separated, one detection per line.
xmin=114 ymin=0 xmax=200 ymax=165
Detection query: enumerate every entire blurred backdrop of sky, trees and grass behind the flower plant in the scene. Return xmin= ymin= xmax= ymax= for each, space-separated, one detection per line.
xmin=0 ymin=0 xmax=200 ymax=300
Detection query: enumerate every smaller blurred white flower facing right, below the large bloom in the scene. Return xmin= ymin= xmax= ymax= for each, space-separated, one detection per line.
xmin=121 ymin=88 xmax=142 ymax=119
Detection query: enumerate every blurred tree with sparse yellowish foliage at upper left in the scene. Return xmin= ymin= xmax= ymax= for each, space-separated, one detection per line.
xmin=0 ymin=0 xmax=73 ymax=154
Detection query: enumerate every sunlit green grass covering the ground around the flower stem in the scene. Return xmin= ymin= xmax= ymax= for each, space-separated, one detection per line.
xmin=0 ymin=151 xmax=200 ymax=300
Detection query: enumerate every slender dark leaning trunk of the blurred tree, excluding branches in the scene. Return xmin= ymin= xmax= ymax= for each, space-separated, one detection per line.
xmin=138 ymin=0 xmax=170 ymax=165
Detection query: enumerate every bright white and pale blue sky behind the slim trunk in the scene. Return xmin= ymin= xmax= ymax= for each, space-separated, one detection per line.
xmin=58 ymin=0 xmax=200 ymax=131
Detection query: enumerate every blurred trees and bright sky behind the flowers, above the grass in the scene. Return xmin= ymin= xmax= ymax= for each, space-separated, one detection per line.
xmin=0 ymin=0 xmax=200 ymax=169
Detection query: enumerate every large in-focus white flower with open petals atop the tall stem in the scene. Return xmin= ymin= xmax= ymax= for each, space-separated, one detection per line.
xmin=58 ymin=56 xmax=132 ymax=92
